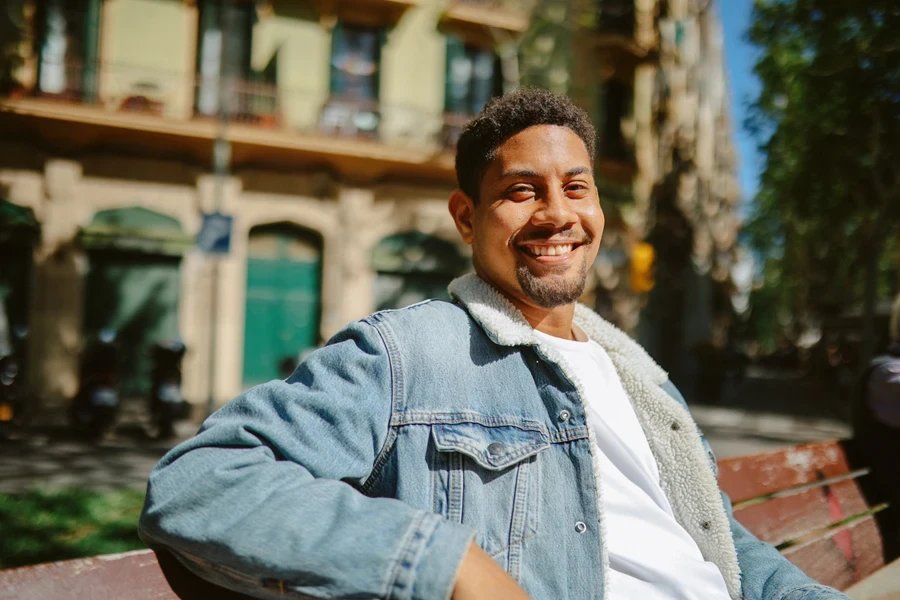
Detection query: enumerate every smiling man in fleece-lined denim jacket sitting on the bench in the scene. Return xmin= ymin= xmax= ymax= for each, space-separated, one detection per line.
xmin=141 ymin=90 xmax=843 ymax=600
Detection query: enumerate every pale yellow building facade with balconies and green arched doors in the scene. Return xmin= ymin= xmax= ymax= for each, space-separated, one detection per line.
xmin=0 ymin=0 xmax=528 ymax=406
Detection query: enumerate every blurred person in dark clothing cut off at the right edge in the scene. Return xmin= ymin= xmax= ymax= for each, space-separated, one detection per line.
xmin=853 ymin=294 xmax=900 ymax=560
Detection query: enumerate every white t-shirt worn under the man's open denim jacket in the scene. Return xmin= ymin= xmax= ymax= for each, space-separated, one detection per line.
xmin=535 ymin=331 xmax=729 ymax=600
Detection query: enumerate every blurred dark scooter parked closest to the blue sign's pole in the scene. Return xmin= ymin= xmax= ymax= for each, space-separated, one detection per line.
xmin=149 ymin=337 xmax=187 ymax=439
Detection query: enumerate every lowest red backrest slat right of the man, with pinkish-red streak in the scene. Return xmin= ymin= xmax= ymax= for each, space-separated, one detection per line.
xmin=784 ymin=517 xmax=884 ymax=590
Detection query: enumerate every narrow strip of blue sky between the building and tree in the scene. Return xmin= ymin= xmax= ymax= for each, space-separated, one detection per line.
xmin=718 ymin=0 xmax=762 ymax=207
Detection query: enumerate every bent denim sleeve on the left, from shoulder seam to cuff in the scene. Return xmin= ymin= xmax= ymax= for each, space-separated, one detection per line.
xmin=139 ymin=322 xmax=474 ymax=600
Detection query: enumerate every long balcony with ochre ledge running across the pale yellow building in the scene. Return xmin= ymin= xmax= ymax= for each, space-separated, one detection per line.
xmin=0 ymin=64 xmax=458 ymax=183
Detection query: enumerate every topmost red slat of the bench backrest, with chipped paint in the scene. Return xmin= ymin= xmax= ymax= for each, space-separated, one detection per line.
xmin=718 ymin=441 xmax=850 ymax=502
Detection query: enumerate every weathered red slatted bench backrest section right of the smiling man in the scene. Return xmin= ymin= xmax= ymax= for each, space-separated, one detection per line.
xmin=719 ymin=441 xmax=887 ymax=589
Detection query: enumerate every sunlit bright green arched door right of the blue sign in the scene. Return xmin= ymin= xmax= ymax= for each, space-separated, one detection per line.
xmin=244 ymin=224 xmax=322 ymax=387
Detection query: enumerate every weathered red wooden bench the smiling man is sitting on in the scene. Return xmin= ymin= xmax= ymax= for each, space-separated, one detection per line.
xmin=0 ymin=442 xmax=900 ymax=600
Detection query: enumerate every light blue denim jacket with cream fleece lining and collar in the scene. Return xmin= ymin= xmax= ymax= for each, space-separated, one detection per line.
xmin=140 ymin=275 xmax=846 ymax=600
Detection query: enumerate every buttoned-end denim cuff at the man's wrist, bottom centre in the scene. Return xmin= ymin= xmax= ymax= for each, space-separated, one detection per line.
xmin=388 ymin=513 xmax=475 ymax=600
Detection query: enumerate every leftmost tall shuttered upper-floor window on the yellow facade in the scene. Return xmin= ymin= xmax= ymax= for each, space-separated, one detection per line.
xmin=35 ymin=0 xmax=101 ymax=101
